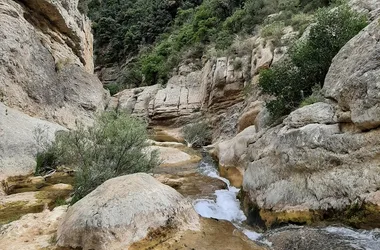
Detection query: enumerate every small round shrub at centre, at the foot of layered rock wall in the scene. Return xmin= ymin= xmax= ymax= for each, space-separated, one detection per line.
xmin=182 ymin=122 xmax=211 ymax=148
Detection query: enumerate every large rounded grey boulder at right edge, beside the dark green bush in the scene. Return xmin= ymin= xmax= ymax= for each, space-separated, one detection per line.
xmin=323 ymin=19 xmax=380 ymax=130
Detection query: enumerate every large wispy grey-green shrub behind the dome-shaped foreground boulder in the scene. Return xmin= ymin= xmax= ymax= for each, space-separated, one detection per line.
xmin=37 ymin=112 xmax=158 ymax=202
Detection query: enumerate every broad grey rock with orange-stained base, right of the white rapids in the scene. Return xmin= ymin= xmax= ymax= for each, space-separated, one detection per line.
xmin=243 ymin=120 xmax=380 ymax=227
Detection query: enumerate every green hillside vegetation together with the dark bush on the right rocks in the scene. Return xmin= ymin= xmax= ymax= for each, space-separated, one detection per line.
xmin=82 ymin=0 xmax=367 ymax=118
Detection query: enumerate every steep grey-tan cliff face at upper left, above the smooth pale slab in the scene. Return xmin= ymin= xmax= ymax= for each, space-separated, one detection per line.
xmin=0 ymin=0 xmax=105 ymax=127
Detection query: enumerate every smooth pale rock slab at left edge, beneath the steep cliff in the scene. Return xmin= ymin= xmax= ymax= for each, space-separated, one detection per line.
xmin=0 ymin=102 xmax=66 ymax=180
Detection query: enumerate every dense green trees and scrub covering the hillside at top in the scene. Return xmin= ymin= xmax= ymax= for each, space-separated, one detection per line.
xmin=82 ymin=0 xmax=330 ymax=92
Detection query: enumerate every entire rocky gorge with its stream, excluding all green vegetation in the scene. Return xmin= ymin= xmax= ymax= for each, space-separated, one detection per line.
xmin=0 ymin=0 xmax=380 ymax=250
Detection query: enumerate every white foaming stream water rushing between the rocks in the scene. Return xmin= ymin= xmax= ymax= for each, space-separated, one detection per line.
xmin=194 ymin=157 xmax=380 ymax=250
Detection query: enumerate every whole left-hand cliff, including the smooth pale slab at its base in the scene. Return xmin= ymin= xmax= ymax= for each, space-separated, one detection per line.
xmin=0 ymin=0 xmax=106 ymax=180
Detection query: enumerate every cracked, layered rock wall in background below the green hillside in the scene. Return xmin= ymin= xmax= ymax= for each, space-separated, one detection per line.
xmin=108 ymin=57 xmax=249 ymax=125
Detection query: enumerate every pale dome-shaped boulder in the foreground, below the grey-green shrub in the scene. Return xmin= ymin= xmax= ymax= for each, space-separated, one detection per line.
xmin=57 ymin=174 xmax=199 ymax=250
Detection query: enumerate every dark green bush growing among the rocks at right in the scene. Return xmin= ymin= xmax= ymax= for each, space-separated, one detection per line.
xmin=259 ymin=6 xmax=367 ymax=122
